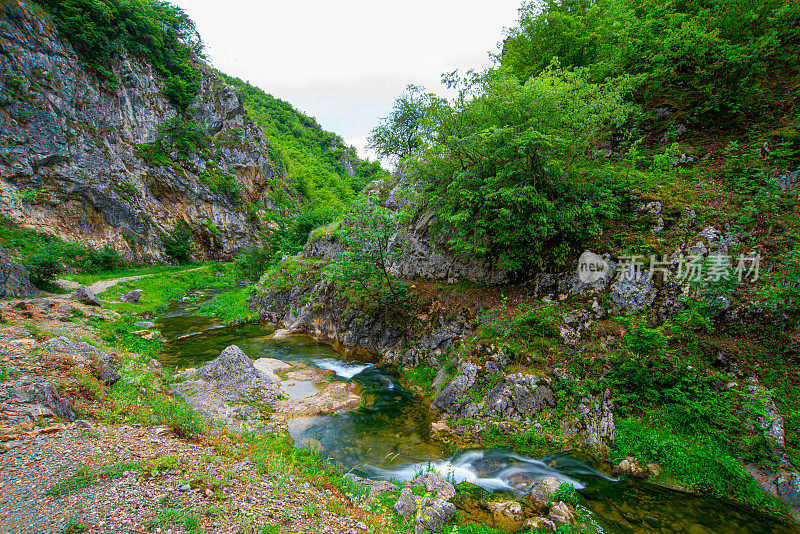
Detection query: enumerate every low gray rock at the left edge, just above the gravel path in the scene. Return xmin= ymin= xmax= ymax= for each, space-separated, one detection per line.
xmin=0 ymin=377 xmax=75 ymax=425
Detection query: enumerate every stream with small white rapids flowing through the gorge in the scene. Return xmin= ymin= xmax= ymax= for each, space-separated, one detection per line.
xmin=158 ymin=299 xmax=796 ymax=534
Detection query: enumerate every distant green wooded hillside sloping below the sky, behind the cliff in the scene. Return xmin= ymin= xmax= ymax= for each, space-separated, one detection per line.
xmin=219 ymin=73 xmax=387 ymax=209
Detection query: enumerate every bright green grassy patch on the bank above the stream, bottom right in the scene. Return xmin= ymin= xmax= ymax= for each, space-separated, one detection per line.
xmin=615 ymin=420 xmax=788 ymax=514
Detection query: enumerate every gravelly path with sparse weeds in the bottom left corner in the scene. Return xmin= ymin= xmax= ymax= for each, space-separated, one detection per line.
xmin=0 ymin=421 xmax=366 ymax=533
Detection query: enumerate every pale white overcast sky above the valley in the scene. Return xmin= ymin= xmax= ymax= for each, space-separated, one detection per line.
xmin=172 ymin=0 xmax=521 ymax=159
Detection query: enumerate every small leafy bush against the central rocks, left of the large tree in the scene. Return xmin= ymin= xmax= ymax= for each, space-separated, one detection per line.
xmin=327 ymin=196 xmax=408 ymax=310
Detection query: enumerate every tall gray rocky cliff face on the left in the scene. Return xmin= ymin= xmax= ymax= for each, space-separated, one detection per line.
xmin=0 ymin=2 xmax=283 ymax=261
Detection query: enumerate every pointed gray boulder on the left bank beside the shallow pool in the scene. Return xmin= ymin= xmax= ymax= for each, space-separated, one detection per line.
xmin=173 ymin=345 xmax=280 ymax=423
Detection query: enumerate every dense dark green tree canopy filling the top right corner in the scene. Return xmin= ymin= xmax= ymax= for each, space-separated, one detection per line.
xmin=501 ymin=0 xmax=800 ymax=121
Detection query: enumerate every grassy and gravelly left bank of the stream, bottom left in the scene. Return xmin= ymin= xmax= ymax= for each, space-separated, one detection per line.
xmin=0 ymin=276 xmax=412 ymax=533
